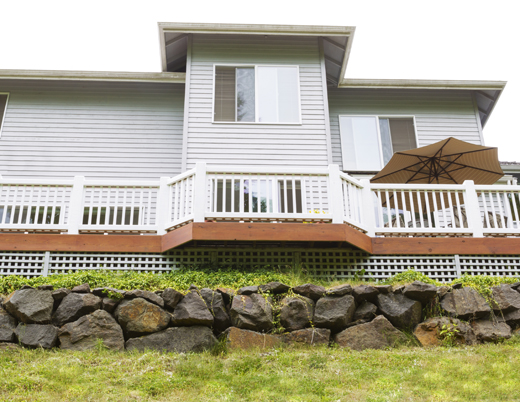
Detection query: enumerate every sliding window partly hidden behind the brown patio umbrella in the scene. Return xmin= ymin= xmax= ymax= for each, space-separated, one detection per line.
xmin=339 ymin=116 xmax=417 ymax=171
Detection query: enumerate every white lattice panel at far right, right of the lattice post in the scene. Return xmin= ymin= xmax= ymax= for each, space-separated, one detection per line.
xmin=460 ymin=255 xmax=520 ymax=276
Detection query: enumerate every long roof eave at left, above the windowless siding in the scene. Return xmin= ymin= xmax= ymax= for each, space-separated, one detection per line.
xmin=0 ymin=70 xmax=186 ymax=84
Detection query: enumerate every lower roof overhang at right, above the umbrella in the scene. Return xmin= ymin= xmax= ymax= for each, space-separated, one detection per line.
xmin=338 ymin=78 xmax=507 ymax=127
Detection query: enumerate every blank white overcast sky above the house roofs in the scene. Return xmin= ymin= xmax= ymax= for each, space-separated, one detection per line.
xmin=0 ymin=0 xmax=520 ymax=162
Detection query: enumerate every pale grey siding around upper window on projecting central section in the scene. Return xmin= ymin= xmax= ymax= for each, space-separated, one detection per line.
xmin=187 ymin=35 xmax=327 ymax=169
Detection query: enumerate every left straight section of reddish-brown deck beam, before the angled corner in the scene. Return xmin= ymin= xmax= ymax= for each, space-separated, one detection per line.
xmin=0 ymin=233 xmax=162 ymax=253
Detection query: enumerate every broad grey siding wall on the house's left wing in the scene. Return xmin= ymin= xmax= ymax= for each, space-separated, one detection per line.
xmin=0 ymin=80 xmax=184 ymax=179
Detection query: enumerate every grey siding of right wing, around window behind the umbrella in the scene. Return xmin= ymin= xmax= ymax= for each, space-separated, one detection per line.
xmin=328 ymin=88 xmax=481 ymax=166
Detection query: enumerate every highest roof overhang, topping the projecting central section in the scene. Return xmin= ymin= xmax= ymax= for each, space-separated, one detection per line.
xmin=158 ymin=22 xmax=356 ymax=85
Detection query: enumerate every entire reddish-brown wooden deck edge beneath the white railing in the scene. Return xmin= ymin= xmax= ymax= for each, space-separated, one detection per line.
xmin=0 ymin=222 xmax=520 ymax=255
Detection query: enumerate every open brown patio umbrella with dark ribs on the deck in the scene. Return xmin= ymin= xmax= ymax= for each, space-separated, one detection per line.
xmin=370 ymin=137 xmax=504 ymax=184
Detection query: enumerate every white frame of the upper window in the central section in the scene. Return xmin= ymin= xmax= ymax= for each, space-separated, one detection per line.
xmin=211 ymin=63 xmax=302 ymax=126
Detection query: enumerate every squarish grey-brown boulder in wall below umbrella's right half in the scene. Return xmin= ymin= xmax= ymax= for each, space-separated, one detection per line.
xmin=441 ymin=287 xmax=491 ymax=320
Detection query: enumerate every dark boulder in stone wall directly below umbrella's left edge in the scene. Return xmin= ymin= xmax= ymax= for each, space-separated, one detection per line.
xmin=377 ymin=293 xmax=422 ymax=330
